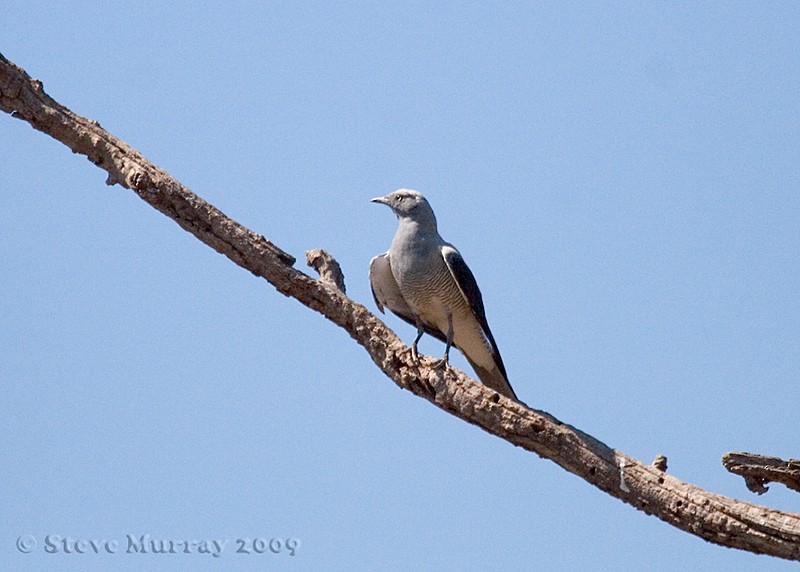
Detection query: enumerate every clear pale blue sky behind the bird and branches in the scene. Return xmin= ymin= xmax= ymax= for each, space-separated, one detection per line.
xmin=0 ymin=0 xmax=800 ymax=572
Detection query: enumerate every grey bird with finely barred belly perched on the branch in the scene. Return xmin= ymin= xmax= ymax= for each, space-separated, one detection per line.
xmin=369 ymin=189 xmax=517 ymax=400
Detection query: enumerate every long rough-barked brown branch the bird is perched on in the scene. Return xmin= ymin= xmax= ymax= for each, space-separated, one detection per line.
xmin=0 ymin=55 xmax=800 ymax=560
